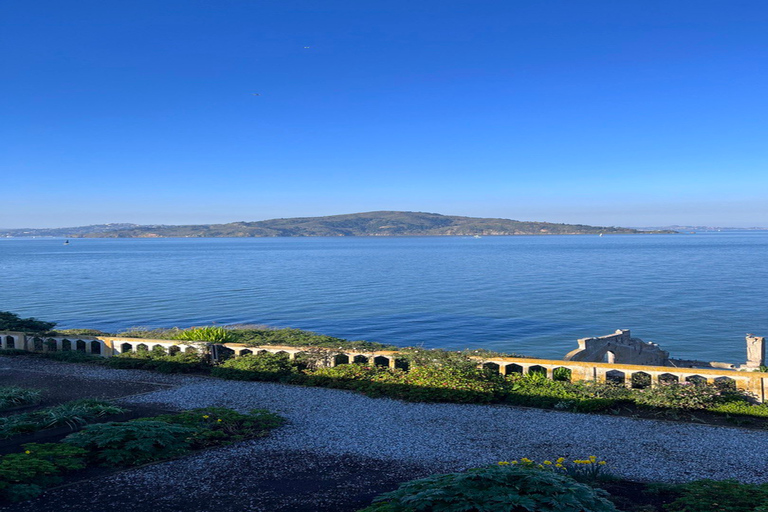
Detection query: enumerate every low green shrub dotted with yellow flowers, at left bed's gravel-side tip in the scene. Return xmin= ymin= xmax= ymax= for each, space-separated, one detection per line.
xmin=136 ymin=407 xmax=284 ymax=448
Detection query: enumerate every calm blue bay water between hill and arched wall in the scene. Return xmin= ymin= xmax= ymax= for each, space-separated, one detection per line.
xmin=0 ymin=232 xmax=768 ymax=362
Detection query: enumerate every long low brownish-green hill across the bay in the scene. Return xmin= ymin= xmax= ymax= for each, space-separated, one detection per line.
xmin=0 ymin=211 xmax=674 ymax=238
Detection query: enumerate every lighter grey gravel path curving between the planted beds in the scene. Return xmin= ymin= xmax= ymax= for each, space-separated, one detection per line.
xmin=0 ymin=358 xmax=768 ymax=511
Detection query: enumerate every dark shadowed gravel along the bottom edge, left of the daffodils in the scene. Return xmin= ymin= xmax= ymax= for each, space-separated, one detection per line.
xmin=0 ymin=446 xmax=434 ymax=512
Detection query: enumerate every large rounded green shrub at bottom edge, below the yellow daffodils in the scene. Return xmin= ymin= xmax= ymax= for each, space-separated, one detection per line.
xmin=363 ymin=465 xmax=616 ymax=512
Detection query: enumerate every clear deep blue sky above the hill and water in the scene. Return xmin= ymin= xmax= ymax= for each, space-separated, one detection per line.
xmin=0 ymin=0 xmax=768 ymax=228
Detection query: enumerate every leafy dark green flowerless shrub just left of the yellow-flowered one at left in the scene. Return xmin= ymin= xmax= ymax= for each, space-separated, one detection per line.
xmin=64 ymin=421 xmax=195 ymax=466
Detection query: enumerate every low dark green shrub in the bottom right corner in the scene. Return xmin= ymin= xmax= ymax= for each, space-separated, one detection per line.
xmin=664 ymin=480 xmax=768 ymax=512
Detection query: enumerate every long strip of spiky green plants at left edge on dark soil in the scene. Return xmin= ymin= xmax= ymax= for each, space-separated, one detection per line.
xmin=0 ymin=399 xmax=126 ymax=439
